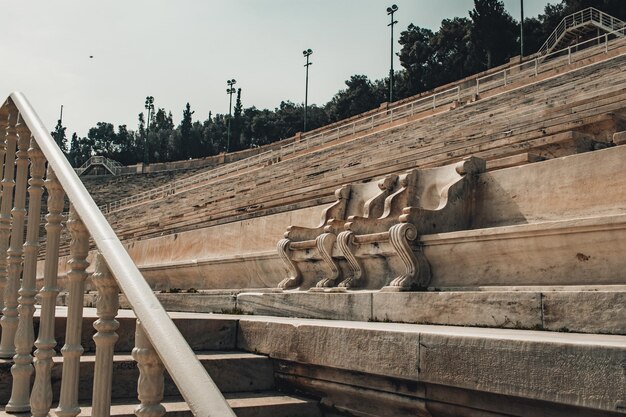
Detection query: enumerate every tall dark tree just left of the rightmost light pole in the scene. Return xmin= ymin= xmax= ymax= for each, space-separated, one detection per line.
xmin=470 ymin=0 xmax=518 ymax=68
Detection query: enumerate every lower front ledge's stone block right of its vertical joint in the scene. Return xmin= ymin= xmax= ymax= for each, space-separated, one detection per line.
xmin=420 ymin=332 xmax=626 ymax=411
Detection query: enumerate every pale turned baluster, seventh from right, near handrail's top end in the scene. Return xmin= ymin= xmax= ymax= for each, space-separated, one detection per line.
xmin=0 ymin=111 xmax=17 ymax=320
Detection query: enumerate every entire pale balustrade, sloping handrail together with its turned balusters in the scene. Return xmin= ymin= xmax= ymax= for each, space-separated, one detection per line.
xmin=0 ymin=93 xmax=235 ymax=417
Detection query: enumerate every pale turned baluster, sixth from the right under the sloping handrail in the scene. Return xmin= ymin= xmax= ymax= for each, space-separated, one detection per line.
xmin=0 ymin=120 xmax=30 ymax=358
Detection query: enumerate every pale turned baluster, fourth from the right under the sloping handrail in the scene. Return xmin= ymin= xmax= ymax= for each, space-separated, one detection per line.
xmin=30 ymin=167 xmax=64 ymax=417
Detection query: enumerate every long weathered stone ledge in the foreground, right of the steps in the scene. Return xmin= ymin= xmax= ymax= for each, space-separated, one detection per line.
xmin=233 ymin=316 xmax=626 ymax=412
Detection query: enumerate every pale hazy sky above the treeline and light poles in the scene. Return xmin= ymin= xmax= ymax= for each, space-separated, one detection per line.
xmin=0 ymin=0 xmax=557 ymax=137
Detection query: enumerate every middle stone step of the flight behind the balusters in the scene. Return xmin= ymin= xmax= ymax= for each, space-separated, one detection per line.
xmin=0 ymin=352 xmax=274 ymax=401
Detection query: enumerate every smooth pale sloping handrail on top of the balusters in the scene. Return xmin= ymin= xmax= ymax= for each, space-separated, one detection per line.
xmin=7 ymin=92 xmax=235 ymax=417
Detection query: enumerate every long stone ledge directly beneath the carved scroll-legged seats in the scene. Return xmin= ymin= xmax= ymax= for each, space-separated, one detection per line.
xmin=72 ymin=286 xmax=626 ymax=335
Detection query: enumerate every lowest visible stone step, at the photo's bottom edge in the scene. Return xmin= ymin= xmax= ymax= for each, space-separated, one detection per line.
xmin=0 ymin=391 xmax=322 ymax=417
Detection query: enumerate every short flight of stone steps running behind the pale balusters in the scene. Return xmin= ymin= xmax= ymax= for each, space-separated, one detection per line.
xmin=0 ymin=310 xmax=322 ymax=417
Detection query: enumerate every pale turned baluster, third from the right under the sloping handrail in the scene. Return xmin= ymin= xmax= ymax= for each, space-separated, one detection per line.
xmin=56 ymin=205 xmax=89 ymax=417
